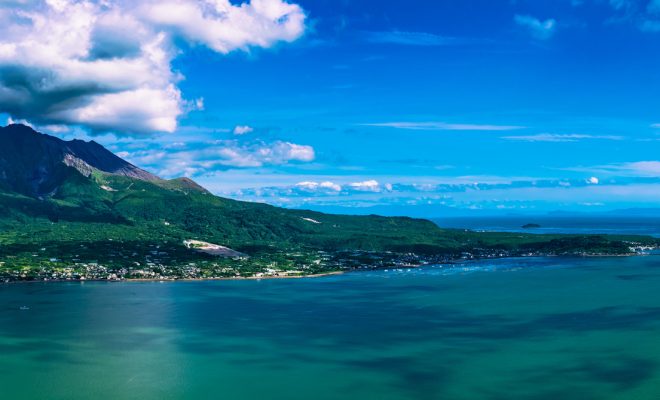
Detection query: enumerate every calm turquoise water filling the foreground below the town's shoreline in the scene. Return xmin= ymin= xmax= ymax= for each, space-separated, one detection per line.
xmin=0 ymin=256 xmax=660 ymax=400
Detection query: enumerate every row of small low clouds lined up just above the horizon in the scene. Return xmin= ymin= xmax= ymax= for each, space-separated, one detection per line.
xmin=227 ymin=175 xmax=660 ymax=211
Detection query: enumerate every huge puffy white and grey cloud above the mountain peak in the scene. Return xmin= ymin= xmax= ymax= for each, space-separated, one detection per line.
xmin=0 ymin=0 xmax=305 ymax=133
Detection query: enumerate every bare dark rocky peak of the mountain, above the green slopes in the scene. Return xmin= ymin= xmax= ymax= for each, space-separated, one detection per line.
xmin=0 ymin=124 xmax=160 ymax=197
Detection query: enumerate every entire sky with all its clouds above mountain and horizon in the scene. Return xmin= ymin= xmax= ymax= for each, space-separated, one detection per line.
xmin=0 ymin=0 xmax=660 ymax=214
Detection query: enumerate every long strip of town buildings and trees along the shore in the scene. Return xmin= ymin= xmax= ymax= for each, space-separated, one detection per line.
xmin=0 ymin=239 xmax=656 ymax=283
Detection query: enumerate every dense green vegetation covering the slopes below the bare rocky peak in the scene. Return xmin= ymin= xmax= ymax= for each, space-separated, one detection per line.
xmin=0 ymin=169 xmax=655 ymax=279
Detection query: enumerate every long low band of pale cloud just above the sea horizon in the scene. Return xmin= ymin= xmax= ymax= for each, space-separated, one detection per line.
xmin=217 ymin=176 xmax=660 ymax=212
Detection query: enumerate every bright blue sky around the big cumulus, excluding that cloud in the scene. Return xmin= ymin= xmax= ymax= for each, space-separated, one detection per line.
xmin=0 ymin=0 xmax=660 ymax=216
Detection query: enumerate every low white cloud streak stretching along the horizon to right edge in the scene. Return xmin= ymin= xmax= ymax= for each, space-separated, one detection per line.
xmin=222 ymin=176 xmax=660 ymax=212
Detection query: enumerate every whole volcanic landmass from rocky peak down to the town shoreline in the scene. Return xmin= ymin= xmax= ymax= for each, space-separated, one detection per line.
xmin=0 ymin=125 xmax=660 ymax=282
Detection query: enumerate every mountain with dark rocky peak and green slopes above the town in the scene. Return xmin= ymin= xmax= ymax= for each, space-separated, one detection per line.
xmin=0 ymin=125 xmax=452 ymax=249
